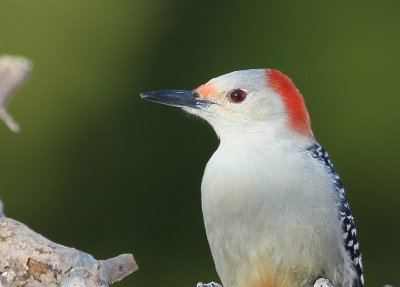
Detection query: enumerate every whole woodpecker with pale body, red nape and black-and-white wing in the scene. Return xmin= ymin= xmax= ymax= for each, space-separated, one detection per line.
xmin=141 ymin=69 xmax=364 ymax=287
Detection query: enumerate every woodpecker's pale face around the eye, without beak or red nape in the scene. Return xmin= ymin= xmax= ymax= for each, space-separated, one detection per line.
xmin=188 ymin=69 xmax=286 ymax=131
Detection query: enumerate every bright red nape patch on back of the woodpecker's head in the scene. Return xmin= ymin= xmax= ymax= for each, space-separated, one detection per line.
xmin=265 ymin=69 xmax=313 ymax=137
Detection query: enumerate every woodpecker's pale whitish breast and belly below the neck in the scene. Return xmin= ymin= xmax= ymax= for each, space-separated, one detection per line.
xmin=202 ymin=144 xmax=343 ymax=287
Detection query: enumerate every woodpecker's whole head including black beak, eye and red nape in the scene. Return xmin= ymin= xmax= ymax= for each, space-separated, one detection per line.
xmin=141 ymin=69 xmax=313 ymax=140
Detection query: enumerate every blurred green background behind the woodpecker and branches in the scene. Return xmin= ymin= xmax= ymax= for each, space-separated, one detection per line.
xmin=0 ymin=0 xmax=400 ymax=286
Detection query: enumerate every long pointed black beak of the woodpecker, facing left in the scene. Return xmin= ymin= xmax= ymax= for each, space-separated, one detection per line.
xmin=140 ymin=90 xmax=212 ymax=109
